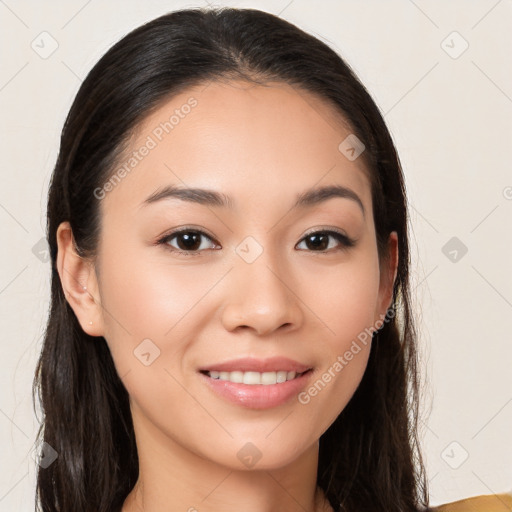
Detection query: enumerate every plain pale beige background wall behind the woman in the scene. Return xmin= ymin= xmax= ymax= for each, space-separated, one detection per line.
xmin=0 ymin=0 xmax=512 ymax=512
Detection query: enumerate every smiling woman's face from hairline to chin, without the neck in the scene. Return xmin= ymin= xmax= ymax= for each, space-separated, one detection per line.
xmin=85 ymin=82 xmax=396 ymax=469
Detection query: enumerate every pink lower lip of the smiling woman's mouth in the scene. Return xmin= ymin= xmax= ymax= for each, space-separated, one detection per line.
xmin=199 ymin=370 xmax=312 ymax=409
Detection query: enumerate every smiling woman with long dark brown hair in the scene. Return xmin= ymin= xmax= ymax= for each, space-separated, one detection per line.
xmin=34 ymin=9 xmax=434 ymax=512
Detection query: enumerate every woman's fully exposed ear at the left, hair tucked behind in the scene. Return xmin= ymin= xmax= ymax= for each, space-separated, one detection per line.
xmin=57 ymin=221 xmax=104 ymax=336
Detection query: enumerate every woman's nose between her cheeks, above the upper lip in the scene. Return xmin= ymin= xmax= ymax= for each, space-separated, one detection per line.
xmin=222 ymin=251 xmax=303 ymax=336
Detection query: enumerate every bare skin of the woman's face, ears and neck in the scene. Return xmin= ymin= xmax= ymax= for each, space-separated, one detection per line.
xmin=57 ymin=82 xmax=398 ymax=512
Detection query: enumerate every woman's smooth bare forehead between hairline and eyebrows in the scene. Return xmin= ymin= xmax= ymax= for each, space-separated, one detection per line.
xmin=102 ymin=81 xmax=371 ymax=218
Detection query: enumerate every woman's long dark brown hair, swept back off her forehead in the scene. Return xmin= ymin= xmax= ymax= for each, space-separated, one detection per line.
xmin=33 ymin=8 xmax=428 ymax=512
